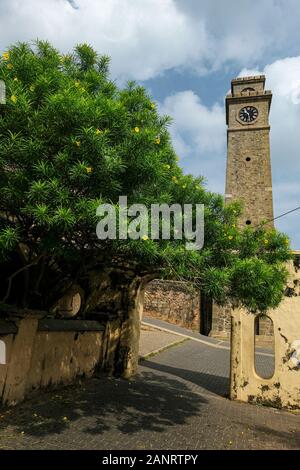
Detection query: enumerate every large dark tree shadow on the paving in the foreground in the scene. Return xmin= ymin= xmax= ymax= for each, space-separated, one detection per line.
xmin=0 ymin=371 xmax=207 ymax=439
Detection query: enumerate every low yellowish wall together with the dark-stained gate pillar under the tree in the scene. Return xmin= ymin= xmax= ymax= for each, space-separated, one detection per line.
xmin=0 ymin=268 xmax=153 ymax=404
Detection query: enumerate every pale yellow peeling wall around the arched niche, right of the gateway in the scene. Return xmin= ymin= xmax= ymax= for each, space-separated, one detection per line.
xmin=230 ymin=297 xmax=300 ymax=409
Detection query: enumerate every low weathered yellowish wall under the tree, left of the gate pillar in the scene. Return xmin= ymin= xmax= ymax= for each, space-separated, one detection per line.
xmin=0 ymin=317 xmax=106 ymax=405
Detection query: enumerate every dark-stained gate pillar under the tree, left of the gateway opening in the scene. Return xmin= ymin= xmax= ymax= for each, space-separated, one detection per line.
xmin=86 ymin=269 xmax=155 ymax=378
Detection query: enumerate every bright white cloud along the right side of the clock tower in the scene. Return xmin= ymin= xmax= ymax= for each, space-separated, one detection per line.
xmin=240 ymin=56 xmax=300 ymax=249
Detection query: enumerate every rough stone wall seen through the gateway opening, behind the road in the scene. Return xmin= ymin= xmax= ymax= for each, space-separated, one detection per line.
xmin=144 ymin=279 xmax=200 ymax=331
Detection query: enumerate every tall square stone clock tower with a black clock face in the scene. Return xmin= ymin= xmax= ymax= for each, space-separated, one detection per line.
xmin=225 ymin=75 xmax=274 ymax=228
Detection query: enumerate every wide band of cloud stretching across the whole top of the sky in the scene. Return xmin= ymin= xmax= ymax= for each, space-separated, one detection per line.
xmin=0 ymin=0 xmax=300 ymax=80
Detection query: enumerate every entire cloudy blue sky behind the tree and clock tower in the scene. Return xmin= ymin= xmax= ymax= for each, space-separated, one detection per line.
xmin=0 ymin=0 xmax=300 ymax=249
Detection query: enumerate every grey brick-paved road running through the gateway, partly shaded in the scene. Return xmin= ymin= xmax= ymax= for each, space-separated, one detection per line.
xmin=0 ymin=320 xmax=300 ymax=450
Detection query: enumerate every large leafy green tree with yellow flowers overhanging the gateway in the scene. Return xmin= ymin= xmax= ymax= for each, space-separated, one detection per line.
xmin=0 ymin=41 xmax=290 ymax=322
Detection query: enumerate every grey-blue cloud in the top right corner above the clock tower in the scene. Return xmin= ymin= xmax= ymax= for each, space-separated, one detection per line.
xmin=175 ymin=0 xmax=300 ymax=69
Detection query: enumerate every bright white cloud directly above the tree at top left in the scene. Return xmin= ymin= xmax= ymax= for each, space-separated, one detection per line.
xmin=0 ymin=0 xmax=206 ymax=80
